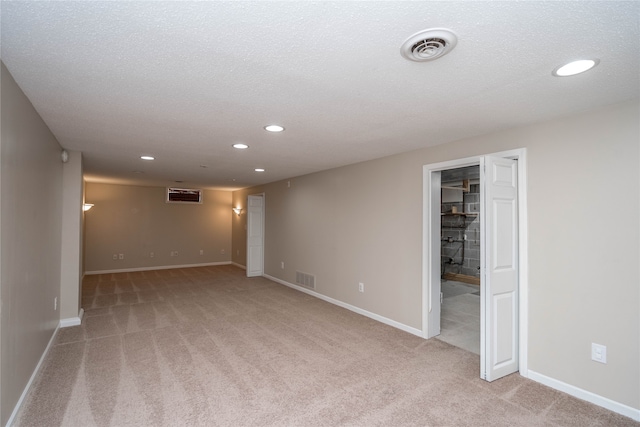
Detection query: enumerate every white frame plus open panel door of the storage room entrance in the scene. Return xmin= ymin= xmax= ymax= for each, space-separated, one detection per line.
xmin=423 ymin=149 xmax=528 ymax=381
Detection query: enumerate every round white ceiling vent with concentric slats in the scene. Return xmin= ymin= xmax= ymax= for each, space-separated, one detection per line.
xmin=400 ymin=28 xmax=458 ymax=62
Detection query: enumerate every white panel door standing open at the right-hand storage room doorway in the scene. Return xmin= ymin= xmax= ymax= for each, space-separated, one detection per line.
xmin=480 ymin=156 xmax=518 ymax=381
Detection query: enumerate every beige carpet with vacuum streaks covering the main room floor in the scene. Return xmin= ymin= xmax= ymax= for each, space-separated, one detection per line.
xmin=15 ymin=266 xmax=638 ymax=427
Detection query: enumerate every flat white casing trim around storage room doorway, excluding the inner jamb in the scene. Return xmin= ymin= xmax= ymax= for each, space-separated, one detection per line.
xmin=421 ymin=148 xmax=529 ymax=377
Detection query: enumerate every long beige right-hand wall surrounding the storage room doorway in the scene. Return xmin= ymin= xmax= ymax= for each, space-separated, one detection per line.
xmin=233 ymin=101 xmax=640 ymax=409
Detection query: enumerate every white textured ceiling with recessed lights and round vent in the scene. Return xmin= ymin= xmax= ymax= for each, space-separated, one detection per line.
xmin=0 ymin=1 xmax=640 ymax=189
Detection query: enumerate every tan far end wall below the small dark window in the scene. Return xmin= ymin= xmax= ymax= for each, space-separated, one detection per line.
xmin=85 ymin=182 xmax=235 ymax=273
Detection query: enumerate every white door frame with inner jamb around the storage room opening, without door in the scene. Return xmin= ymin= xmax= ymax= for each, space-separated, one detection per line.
xmin=422 ymin=148 xmax=529 ymax=377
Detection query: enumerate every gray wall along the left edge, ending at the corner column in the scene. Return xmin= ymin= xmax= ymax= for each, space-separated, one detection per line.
xmin=0 ymin=64 xmax=62 ymax=425
